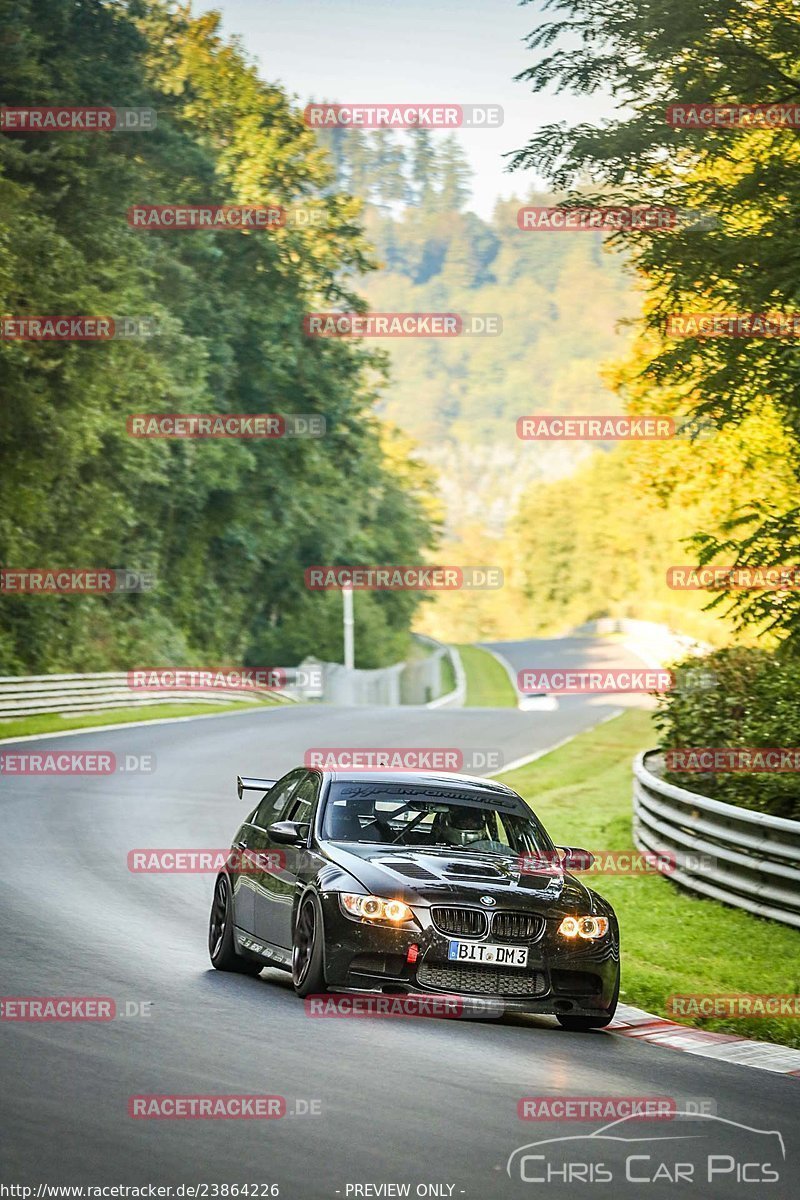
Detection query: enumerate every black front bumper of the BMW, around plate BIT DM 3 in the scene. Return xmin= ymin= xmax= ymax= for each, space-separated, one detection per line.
xmin=321 ymin=893 xmax=619 ymax=1016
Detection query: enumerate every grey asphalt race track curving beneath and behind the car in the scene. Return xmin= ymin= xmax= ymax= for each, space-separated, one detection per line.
xmin=0 ymin=638 xmax=800 ymax=1200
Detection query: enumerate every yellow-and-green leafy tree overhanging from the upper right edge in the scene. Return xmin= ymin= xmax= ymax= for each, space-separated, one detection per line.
xmin=512 ymin=0 xmax=800 ymax=650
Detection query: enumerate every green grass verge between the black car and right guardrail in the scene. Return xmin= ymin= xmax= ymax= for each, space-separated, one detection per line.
xmin=499 ymin=710 xmax=800 ymax=1046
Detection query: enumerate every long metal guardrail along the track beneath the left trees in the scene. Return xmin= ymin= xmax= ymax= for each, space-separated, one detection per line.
xmin=0 ymin=671 xmax=296 ymax=720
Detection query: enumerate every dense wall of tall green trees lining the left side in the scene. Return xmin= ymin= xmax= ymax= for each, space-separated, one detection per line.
xmin=0 ymin=0 xmax=433 ymax=672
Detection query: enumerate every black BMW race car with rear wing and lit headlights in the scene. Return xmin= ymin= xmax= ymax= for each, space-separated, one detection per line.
xmin=209 ymin=767 xmax=619 ymax=1030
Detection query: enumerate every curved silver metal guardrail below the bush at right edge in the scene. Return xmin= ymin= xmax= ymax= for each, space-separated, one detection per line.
xmin=633 ymin=750 xmax=800 ymax=929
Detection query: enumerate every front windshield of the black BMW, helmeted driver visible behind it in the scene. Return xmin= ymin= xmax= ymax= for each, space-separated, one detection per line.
xmin=321 ymin=782 xmax=553 ymax=854
